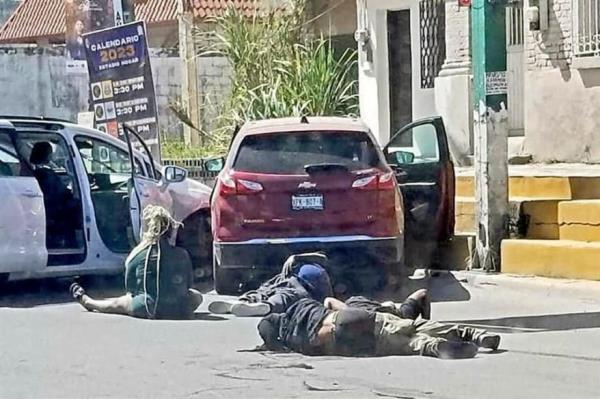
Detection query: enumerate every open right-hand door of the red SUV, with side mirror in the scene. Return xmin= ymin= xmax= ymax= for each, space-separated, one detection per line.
xmin=384 ymin=117 xmax=454 ymax=242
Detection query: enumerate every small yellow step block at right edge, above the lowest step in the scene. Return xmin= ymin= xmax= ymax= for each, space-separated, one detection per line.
xmin=558 ymin=200 xmax=600 ymax=241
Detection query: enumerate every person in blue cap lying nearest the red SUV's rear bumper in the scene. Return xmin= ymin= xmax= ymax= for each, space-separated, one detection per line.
xmin=208 ymin=253 xmax=333 ymax=317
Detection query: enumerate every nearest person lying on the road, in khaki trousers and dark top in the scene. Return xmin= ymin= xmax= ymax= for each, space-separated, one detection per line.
xmin=258 ymin=299 xmax=500 ymax=359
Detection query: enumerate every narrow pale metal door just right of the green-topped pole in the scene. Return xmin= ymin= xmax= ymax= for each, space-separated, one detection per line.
xmin=506 ymin=1 xmax=525 ymax=136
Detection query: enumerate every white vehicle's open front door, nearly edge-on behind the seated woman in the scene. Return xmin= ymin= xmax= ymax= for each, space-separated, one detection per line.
xmin=123 ymin=125 xmax=158 ymax=243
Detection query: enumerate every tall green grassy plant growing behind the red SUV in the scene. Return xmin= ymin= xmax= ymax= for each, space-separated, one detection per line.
xmin=190 ymin=0 xmax=358 ymax=146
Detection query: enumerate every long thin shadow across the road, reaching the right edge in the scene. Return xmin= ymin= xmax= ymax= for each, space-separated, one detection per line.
xmin=448 ymin=312 xmax=600 ymax=333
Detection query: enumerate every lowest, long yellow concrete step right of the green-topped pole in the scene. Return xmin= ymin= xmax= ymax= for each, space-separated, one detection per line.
xmin=501 ymin=240 xmax=600 ymax=280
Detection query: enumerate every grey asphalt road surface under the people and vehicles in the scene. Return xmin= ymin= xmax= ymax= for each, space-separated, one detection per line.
xmin=0 ymin=273 xmax=600 ymax=399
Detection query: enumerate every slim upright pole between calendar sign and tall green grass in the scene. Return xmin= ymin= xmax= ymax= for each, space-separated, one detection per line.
xmin=177 ymin=0 xmax=202 ymax=146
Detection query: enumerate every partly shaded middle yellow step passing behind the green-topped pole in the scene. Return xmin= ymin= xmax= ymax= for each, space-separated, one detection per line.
xmin=455 ymin=197 xmax=561 ymax=240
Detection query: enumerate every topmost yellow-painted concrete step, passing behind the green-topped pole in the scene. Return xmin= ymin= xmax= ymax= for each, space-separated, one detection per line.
xmin=456 ymin=174 xmax=600 ymax=200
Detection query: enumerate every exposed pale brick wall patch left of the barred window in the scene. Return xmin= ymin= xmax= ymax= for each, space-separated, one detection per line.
xmin=524 ymin=0 xmax=573 ymax=71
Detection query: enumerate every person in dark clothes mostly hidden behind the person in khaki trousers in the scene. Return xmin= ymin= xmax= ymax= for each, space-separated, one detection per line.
xmin=323 ymin=288 xmax=431 ymax=320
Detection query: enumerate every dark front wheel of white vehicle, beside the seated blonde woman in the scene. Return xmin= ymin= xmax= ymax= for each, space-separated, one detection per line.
xmin=177 ymin=212 xmax=213 ymax=282
